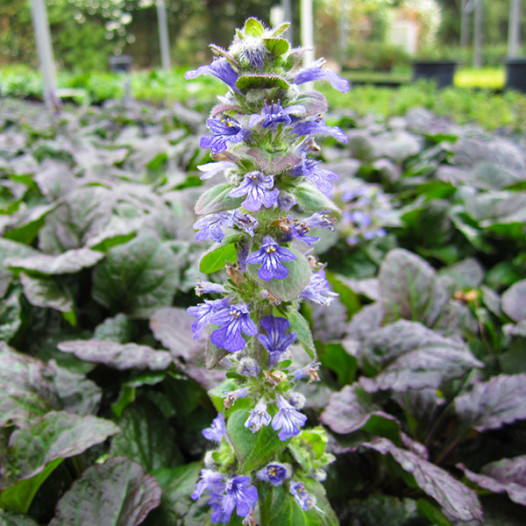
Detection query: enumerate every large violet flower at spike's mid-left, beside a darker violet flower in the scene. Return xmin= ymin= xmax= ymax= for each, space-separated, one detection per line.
xmin=210 ymin=303 xmax=258 ymax=352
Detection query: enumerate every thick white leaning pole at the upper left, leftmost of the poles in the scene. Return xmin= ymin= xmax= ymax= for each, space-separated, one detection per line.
xmin=31 ymin=0 xmax=58 ymax=110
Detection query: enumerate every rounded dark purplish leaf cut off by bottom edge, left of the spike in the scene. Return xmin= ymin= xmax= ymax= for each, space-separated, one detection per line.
xmin=49 ymin=458 xmax=161 ymax=526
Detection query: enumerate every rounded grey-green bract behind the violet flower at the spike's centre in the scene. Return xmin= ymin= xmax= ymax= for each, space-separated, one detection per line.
xmin=248 ymin=249 xmax=311 ymax=301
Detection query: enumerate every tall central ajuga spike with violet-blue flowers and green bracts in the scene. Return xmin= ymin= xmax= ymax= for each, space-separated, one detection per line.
xmin=186 ymin=18 xmax=349 ymax=526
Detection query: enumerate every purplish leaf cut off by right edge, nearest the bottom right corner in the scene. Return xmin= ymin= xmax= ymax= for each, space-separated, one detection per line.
xmin=458 ymin=455 xmax=526 ymax=506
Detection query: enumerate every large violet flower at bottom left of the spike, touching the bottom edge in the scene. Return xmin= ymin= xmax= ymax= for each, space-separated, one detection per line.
xmin=210 ymin=476 xmax=258 ymax=524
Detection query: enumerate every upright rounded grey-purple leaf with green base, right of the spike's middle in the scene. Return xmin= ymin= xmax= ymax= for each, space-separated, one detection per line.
xmin=378 ymin=249 xmax=449 ymax=327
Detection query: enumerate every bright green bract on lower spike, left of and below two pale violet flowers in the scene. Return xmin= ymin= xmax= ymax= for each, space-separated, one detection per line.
xmin=227 ymin=409 xmax=287 ymax=473
